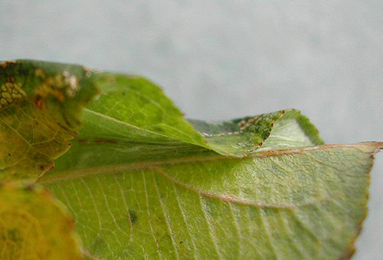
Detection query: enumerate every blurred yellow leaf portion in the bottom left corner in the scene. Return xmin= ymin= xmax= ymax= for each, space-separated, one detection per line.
xmin=0 ymin=184 xmax=81 ymax=260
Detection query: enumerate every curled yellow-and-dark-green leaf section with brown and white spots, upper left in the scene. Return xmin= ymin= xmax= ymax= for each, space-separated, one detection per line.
xmin=0 ymin=61 xmax=96 ymax=181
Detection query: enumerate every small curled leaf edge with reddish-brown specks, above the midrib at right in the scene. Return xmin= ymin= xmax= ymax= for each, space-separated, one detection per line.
xmin=189 ymin=109 xmax=324 ymax=156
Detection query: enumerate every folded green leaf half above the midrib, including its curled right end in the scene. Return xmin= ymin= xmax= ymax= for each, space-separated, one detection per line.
xmin=35 ymin=70 xmax=323 ymax=179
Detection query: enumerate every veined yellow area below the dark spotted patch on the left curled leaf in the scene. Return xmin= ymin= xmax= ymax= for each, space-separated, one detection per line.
xmin=0 ymin=100 xmax=73 ymax=181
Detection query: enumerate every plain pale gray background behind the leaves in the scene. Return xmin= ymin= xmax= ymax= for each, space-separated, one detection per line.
xmin=0 ymin=0 xmax=383 ymax=259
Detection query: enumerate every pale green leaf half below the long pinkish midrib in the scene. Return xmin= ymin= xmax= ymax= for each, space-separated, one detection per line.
xmin=42 ymin=143 xmax=382 ymax=259
